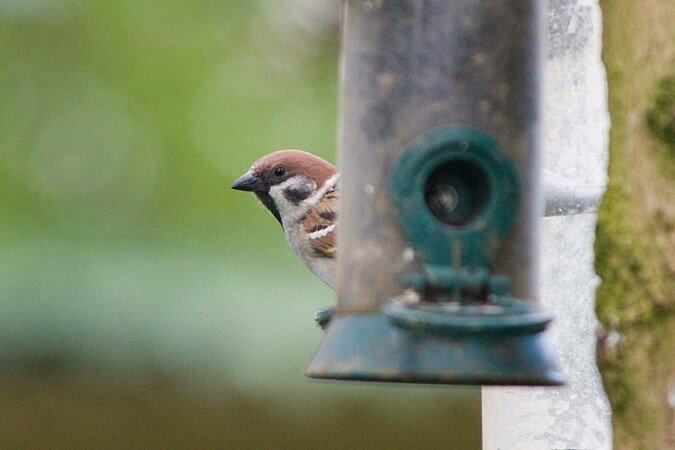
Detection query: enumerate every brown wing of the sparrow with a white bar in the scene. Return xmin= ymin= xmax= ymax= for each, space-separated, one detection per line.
xmin=302 ymin=188 xmax=338 ymax=258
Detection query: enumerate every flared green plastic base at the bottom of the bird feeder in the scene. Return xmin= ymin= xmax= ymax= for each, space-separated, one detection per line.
xmin=306 ymin=312 xmax=564 ymax=386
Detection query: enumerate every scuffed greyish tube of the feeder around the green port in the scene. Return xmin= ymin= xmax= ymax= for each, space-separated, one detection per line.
xmin=338 ymin=0 xmax=542 ymax=314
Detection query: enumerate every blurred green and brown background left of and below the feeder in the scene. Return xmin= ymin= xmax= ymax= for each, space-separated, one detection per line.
xmin=0 ymin=0 xmax=480 ymax=449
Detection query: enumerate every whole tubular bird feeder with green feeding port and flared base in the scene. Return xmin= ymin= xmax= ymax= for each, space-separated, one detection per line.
xmin=307 ymin=0 xmax=564 ymax=385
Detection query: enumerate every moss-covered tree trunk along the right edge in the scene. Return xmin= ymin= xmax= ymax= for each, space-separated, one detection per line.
xmin=595 ymin=0 xmax=675 ymax=449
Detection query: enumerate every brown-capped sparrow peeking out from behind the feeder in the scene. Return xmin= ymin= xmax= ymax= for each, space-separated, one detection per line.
xmin=232 ymin=150 xmax=340 ymax=289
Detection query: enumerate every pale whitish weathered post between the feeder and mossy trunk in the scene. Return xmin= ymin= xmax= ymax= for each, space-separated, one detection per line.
xmin=482 ymin=0 xmax=612 ymax=450
